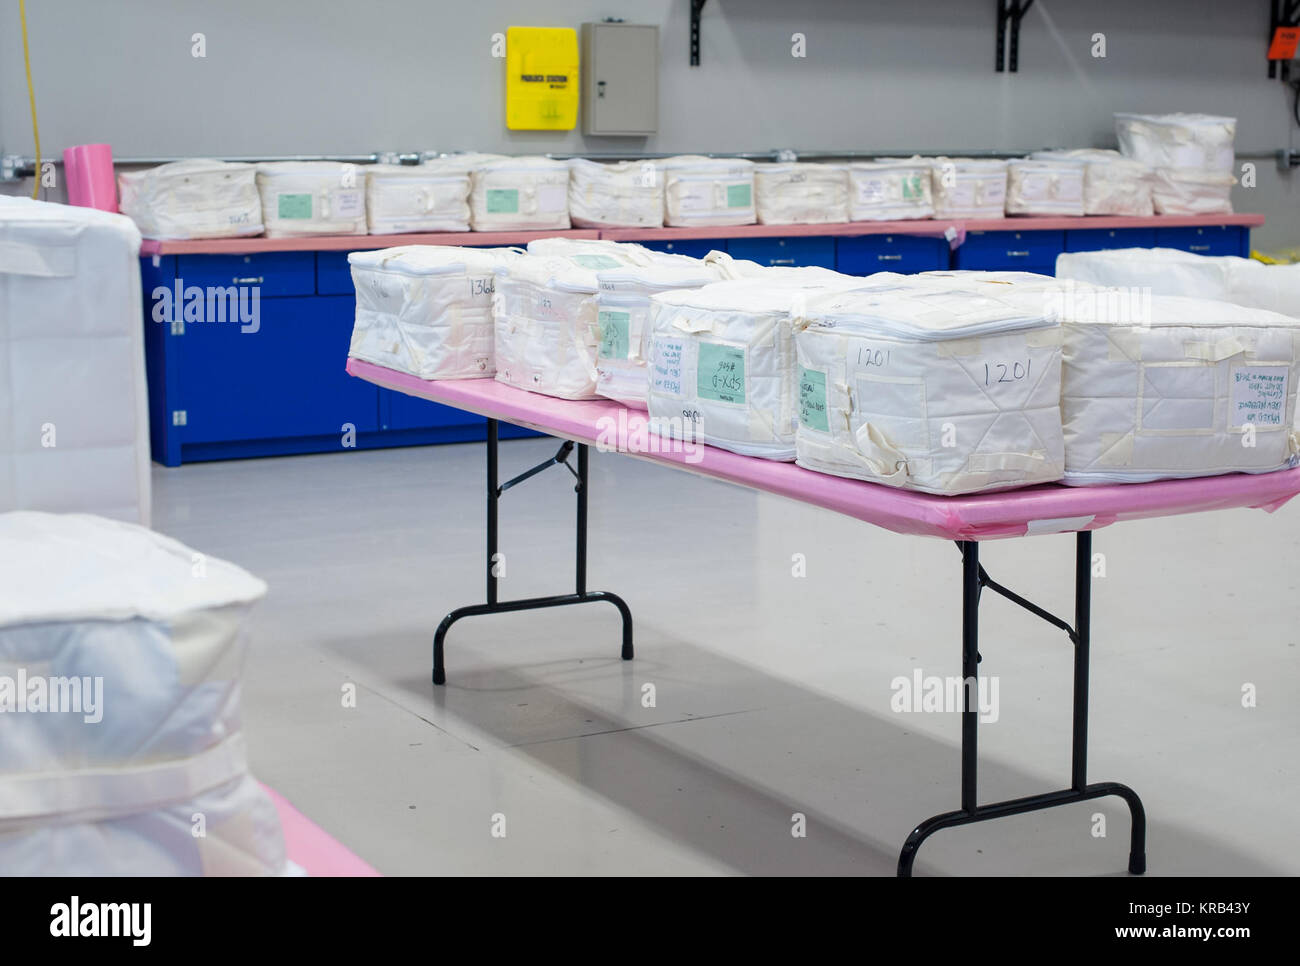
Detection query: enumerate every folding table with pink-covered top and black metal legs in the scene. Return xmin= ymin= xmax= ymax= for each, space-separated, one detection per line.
xmin=347 ymin=359 xmax=1300 ymax=876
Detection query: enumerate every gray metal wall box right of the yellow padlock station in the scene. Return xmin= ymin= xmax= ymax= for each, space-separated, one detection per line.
xmin=581 ymin=23 xmax=659 ymax=135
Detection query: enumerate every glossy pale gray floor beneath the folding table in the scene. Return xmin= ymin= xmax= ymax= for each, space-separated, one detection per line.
xmin=155 ymin=439 xmax=1300 ymax=875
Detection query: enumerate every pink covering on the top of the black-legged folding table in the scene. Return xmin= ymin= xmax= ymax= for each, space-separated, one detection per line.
xmin=347 ymin=359 xmax=1300 ymax=540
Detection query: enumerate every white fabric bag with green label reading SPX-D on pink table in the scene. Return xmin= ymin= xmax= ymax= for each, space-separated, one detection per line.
xmin=647 ymin=269 xmax=861 ymax=460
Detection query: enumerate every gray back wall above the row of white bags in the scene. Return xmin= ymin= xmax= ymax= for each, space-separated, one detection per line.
xmin=0 ymin=0 xmax=1300 ymax=246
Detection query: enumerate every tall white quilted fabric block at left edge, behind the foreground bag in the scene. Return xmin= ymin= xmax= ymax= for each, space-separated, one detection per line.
xmin=0 ymin=196 xmax=153 ymax=527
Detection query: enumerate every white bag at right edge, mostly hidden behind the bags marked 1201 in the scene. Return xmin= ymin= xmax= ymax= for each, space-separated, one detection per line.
xmin=1057 ymin=248 xmax=1300 ymax=319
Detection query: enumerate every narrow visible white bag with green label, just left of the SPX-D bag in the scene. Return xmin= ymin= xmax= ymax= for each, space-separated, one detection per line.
xmin=595 ymin=255 xmax=718 ymax=410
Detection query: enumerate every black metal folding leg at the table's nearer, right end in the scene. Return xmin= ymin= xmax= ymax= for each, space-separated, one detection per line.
xmin=898 ymin=530 xmax=1147 ymax=876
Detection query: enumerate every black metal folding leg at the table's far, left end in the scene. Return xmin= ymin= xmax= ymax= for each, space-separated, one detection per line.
xmin=433 ymin=419 xmax=632 ymax=684
